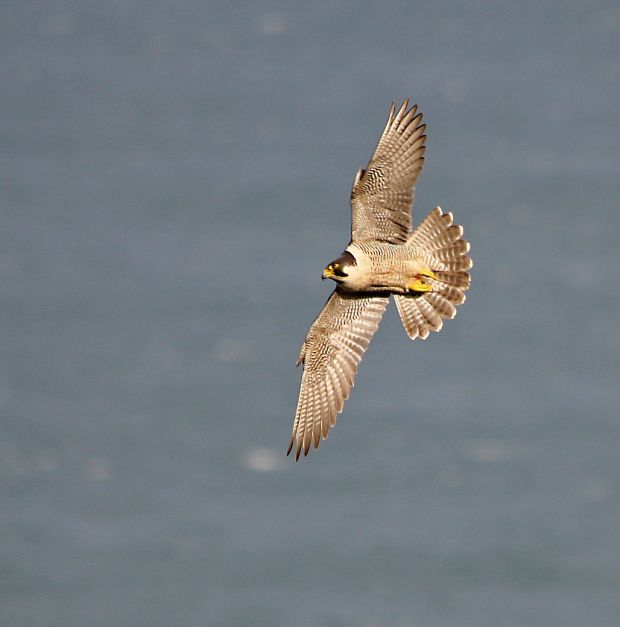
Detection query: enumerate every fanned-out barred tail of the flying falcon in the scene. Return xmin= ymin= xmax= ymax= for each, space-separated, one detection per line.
xmin=394 ymin=207 xmax=472 ymax=340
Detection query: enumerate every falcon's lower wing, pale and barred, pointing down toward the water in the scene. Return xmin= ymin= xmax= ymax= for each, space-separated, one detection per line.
xmin=287 ymin=288 xmax=389 ymax=459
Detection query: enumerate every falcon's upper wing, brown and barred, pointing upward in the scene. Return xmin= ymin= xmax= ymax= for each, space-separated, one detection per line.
xmin=351 ymin=98 xmax=426 ymax=244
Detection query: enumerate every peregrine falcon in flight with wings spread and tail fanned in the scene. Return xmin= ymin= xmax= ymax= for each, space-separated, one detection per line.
xmin=287 ymin=98 xmax=472 ymax=459
